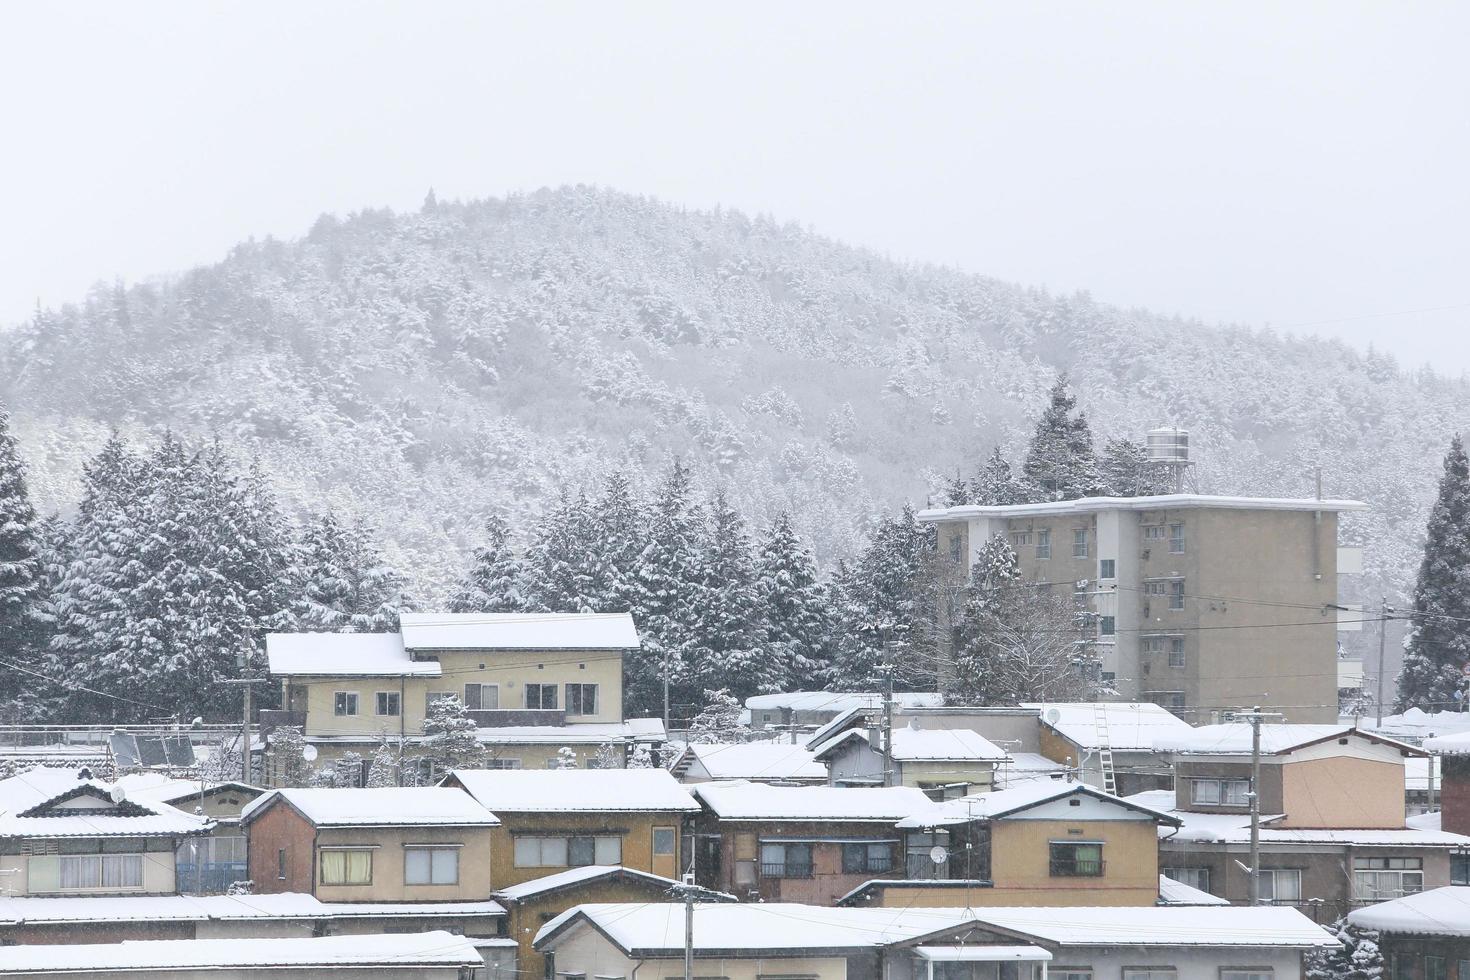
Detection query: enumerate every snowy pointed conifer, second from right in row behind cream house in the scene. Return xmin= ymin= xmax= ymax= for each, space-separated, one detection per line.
xmin=691 ymin=489 xmax=764 ymax=696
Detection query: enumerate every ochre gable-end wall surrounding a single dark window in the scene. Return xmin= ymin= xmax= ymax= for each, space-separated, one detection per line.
xmin=976 ymin=820 xmax=1158 ymax=905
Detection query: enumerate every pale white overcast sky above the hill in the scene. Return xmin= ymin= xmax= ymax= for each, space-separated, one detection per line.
xmin=0 ymin=0 xmax=1470 ymax=373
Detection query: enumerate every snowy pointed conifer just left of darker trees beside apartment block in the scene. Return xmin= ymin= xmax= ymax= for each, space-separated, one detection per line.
xmin=750 ymin=511 xmax=829 ymax=693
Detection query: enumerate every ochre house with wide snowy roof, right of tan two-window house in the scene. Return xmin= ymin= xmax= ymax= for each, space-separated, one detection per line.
xmin=441 ymin=768 xmax=700 ymax=889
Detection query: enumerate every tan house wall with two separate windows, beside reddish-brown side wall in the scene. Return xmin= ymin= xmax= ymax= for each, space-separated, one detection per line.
xmin=313 ymin=827 xmax=494 ymax=902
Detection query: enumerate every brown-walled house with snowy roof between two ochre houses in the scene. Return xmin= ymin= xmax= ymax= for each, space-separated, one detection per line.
xmin=689 ymin=782 xmax=932 ymax=905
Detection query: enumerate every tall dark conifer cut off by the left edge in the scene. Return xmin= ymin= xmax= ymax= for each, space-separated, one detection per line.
xmin=0 ymin=408 xmax=49 ymax=721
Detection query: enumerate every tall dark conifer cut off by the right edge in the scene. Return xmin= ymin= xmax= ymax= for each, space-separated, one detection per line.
xmin=1395 ymin=433 xmax=1470 ymax=711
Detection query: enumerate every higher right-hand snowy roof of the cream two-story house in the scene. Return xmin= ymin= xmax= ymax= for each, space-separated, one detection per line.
xmin=398 ymin=613 xmax=638 ymax=649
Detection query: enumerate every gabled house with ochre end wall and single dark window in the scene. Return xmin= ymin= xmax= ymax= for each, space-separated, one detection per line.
xmin=842 ymin=780 xmax=1179 ymax=907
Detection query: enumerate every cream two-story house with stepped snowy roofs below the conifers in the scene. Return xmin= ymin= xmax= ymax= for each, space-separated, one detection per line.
xmin=266 ymin=613 xmax=663 ymax=768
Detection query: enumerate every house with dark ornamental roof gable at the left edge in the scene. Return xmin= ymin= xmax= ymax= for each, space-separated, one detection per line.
xmin=0 ymin=768 xmax=213 ymax=896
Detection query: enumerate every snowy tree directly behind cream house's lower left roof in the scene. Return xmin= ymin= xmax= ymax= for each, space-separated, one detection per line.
xmin=295 ymin=513 xmax=413 ymax=633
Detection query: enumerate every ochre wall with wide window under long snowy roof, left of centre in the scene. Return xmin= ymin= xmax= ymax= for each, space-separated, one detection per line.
xmin=491 ymin=811 xmax=684 ymax=887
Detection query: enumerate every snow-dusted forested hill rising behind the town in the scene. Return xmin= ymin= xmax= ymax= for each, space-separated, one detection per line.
xmin=0 ymin=188 xmax=1466 ymax=604
